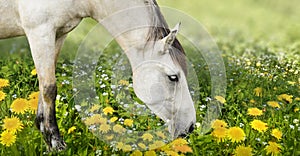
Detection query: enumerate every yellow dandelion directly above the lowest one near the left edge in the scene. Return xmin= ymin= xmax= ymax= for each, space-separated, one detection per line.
xmin=3 ymin=117 xmax=23 ymax=133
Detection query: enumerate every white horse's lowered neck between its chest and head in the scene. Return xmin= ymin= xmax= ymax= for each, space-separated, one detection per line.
xmin=89 ymin=0 xmax=152 ymax=52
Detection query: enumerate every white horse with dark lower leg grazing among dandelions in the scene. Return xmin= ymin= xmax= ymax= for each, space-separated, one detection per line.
xmin=0 ymin=0 xmax=196 ymax=150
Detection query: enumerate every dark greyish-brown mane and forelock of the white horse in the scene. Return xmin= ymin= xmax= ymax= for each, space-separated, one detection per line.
xmin=147 ymin=0 xmax=187 ymax=76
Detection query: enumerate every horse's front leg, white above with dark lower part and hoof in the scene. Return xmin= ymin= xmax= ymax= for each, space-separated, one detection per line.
xmin=26 ymin=25 xmax=66 ymax=150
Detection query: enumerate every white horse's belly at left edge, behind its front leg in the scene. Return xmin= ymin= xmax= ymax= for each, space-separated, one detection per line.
xmin=0 ymin=0 xmax=24 ymax=39
